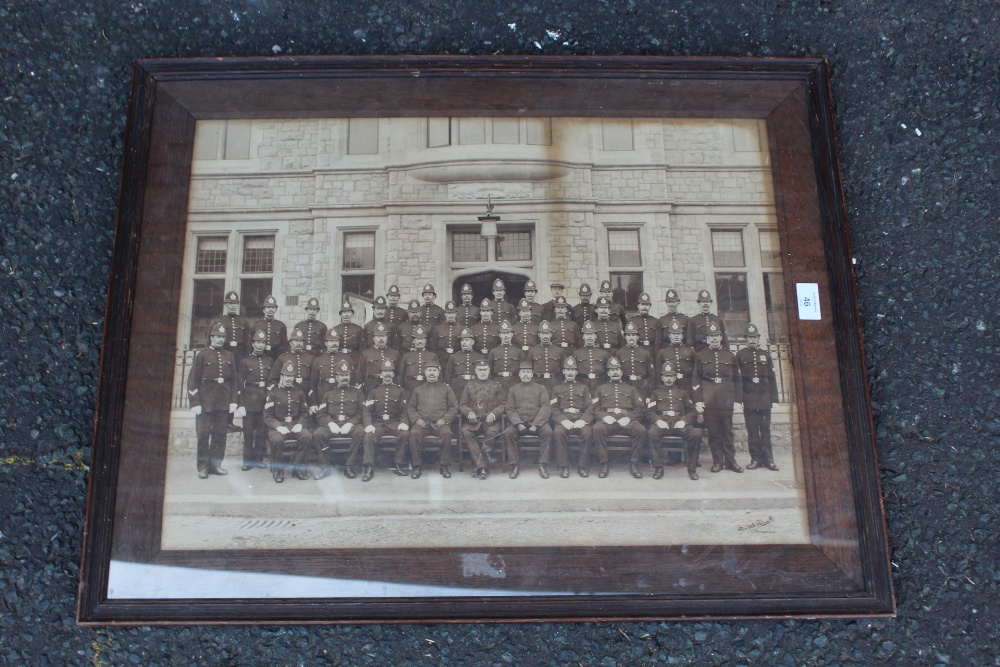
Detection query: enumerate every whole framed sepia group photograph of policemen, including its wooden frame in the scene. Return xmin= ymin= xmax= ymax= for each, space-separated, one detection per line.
xmin=78 ymin=57 xmax=894 ymax=625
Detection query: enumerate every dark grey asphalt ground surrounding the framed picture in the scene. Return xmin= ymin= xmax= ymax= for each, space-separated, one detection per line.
xmin=0 ymin=0 xmax=1000 ymax=667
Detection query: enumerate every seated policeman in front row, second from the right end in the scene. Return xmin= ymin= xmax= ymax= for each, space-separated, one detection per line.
xmin=592 ymin=357 xmax=646 ymax=479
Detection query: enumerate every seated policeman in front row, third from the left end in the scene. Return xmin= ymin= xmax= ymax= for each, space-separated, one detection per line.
xmin=361 ymin=360 xmax=410 ymax=482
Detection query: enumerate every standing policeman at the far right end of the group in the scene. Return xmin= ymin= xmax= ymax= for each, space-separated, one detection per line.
xmin=736 ymin=324 xmax=778 ymax=471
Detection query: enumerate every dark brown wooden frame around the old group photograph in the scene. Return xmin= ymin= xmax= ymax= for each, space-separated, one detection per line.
xmin=78 ymin=56 xmax=895 ymax=625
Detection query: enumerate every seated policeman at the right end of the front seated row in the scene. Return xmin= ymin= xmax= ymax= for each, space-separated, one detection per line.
xmin=646 ymin=361 xmax=701 ymax=480
